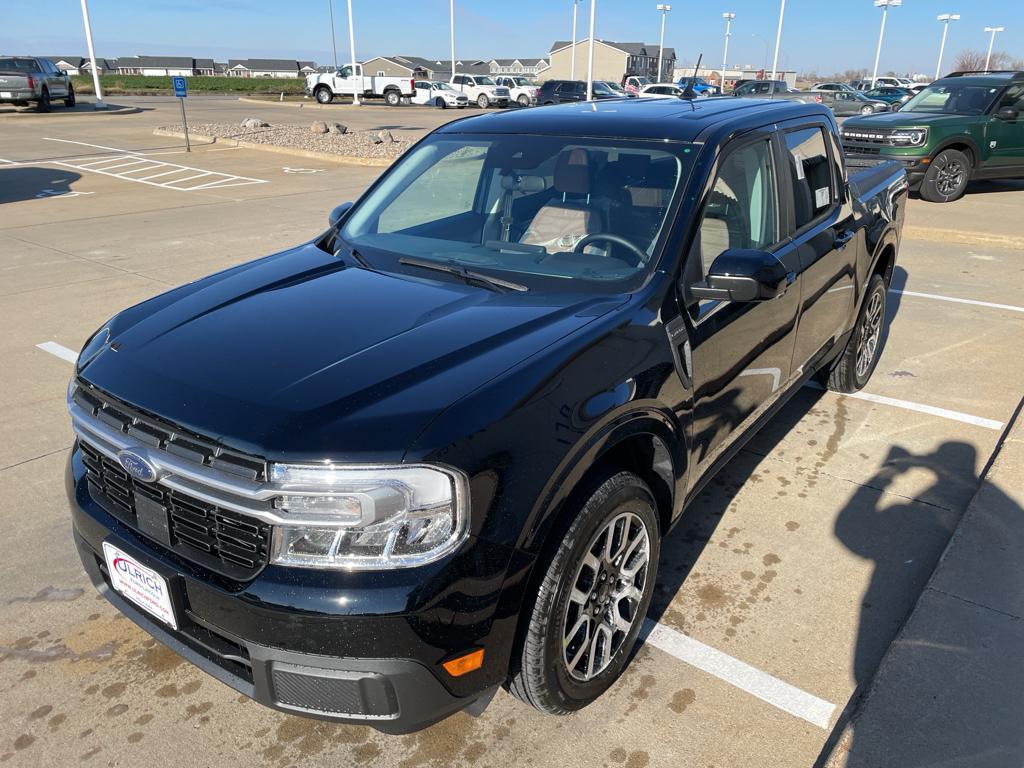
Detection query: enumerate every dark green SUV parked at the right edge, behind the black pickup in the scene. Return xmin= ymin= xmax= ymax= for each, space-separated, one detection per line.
xmin=841 ymin=72 xmax=1024 ymax=203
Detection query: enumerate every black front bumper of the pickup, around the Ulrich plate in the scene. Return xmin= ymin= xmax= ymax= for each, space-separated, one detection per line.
xmin=66 ymin=447 xmax=518 ymax=733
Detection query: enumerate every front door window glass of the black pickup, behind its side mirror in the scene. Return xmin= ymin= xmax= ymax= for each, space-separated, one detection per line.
xmin=687 ymin=139 xmax=778 ymax=282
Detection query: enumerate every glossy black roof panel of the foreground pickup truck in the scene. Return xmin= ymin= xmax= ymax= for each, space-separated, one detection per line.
xmin=437 ymin=98 xmax=833 ymax=141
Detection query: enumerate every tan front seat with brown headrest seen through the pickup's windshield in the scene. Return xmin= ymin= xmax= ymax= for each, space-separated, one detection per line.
xmin=519 ymin=148 xmax=601 ymax=251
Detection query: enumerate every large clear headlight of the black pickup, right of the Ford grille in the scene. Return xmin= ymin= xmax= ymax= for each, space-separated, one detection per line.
xmin=270 ymin=464 xmax=469 ymax=568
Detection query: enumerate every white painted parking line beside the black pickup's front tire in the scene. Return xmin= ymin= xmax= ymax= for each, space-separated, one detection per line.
xmin=644 ymin=618 xmax=836 ymax=730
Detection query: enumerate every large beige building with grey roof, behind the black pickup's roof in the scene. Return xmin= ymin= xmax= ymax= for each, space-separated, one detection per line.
xmin=542 ymin=39 xmax=676 ymax=82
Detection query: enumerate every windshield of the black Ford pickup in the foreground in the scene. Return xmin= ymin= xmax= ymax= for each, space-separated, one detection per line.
xmin=340 ymin=134 xmax=692 ymax=291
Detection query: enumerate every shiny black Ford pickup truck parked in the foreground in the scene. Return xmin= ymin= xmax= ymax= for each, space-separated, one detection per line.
xmin=67 ymin=99 xmax=906 ymax=733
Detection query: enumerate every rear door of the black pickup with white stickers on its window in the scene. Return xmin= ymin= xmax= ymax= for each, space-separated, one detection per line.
xmin=778 ymin=119 xmax=867 ymax=374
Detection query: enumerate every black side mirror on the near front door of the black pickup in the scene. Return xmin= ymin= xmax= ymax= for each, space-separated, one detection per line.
xmin=690 ymin=248 xmax=796 ymax=301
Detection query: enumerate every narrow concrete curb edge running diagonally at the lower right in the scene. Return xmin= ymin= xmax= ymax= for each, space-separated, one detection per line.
xmin=814 ymin=393 xmax=1024 ymax=768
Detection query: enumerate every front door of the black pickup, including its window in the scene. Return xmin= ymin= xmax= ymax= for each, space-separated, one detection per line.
xmin=677 ymin=129 xmax=800 ymax=477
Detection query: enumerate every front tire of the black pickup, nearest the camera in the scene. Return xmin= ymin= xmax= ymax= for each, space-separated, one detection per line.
xmin=508 ymin=472 xmax=660 ymax=715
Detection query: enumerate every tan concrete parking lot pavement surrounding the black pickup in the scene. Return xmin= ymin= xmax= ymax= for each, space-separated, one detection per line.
xmin=0 ymin=97 xmax=1024 ymax=768
